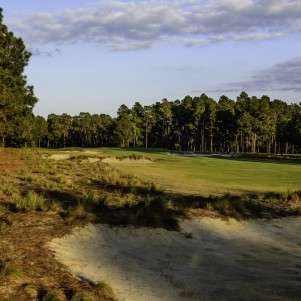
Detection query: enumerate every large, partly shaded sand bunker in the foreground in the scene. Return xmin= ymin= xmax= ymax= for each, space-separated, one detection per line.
xmin=49 ymin=218 xmax=301 ymax=301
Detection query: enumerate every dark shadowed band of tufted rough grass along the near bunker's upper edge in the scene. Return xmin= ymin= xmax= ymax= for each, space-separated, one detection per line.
xmin=0 ymin=172 xmax=301 ymax=231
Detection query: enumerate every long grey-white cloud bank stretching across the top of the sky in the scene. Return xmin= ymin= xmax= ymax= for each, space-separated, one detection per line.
xmin=5 ymin=0 xmax=301 ymax=50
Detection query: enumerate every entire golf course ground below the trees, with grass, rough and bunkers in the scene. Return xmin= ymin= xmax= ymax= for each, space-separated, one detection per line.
xmin=0 ymin=148 xmax=301 ymax=301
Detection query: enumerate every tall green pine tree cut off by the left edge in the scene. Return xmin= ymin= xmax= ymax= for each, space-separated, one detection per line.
xmin=0 ymin=8 xmax=37 ymax=145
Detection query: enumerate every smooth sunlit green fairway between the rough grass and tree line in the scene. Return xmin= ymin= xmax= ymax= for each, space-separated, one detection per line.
xmin=100 ymin=148 xmax=301 ymax=196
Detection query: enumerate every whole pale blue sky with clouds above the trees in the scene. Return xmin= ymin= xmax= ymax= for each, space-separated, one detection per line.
xmin=0 ymin=0 xmax=301 ymax=117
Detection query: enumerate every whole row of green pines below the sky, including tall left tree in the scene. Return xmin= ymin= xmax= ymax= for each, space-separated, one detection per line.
xmin=0 ymin=8 xmax=301 ymax=153
